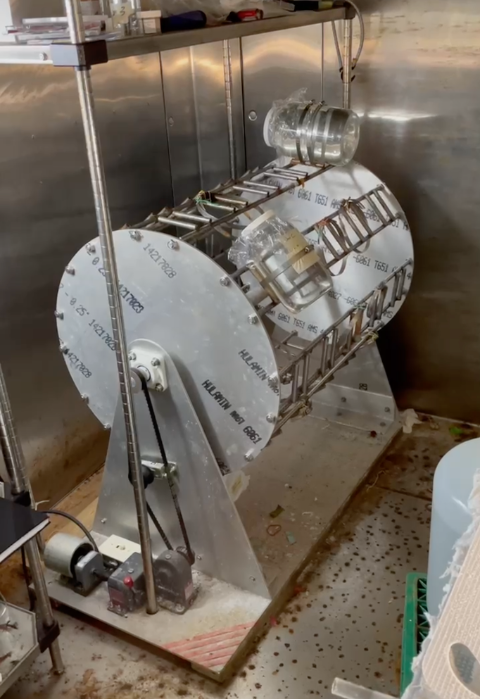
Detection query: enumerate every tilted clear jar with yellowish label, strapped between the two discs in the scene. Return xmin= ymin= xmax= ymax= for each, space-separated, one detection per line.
xmin=229 ymin=211 xmax=332 ymax=313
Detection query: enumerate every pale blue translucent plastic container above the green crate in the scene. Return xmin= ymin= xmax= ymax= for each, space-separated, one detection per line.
xmin=428 ymin=440 xmax=481 ymax=615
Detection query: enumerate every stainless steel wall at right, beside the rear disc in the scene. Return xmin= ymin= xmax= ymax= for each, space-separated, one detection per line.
xmin=353 ymin=0 xmax=480 ymax=422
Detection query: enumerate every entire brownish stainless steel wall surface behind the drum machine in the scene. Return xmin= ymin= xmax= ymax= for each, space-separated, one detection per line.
xmin=0 ymin=0 xmax=479 ymax=506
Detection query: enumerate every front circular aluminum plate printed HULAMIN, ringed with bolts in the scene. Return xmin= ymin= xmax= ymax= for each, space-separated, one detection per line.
xmin=57 ymin=229 xmax=279 ymax=472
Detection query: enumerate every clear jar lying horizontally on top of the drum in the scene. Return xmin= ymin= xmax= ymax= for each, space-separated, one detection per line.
xmin=264 ymin=100 xmax=360 ymax=166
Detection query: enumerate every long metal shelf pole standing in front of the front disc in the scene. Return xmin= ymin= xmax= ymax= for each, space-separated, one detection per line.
xmin=65 ymin=0 xmax=158 ymax=615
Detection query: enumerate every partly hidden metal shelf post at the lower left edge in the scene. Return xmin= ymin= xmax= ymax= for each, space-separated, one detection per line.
xmin=0 ymin=365 xmax=64 ymax=674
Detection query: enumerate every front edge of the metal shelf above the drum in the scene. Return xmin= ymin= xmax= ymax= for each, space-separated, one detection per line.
xmin=0 ymin=7 xmax=347 ymax=65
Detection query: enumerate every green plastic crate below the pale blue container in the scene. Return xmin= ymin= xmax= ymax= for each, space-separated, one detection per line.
xmin=401 ymin=573 xmax=429 ymax=697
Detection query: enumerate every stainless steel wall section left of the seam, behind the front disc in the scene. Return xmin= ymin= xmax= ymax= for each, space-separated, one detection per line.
xmin=0 ymin=55 xmax=171 ymax=499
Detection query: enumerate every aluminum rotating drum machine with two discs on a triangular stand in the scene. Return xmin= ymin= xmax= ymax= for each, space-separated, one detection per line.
xmin=50 ymin=102 xmax=413 ymax=673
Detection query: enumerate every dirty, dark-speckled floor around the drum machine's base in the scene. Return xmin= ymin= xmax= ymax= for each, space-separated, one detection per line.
xmin=2 ymin=412 xmax=478 ymax=698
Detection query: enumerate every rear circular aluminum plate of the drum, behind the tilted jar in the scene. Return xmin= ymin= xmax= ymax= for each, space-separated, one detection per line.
xmin=242 ymin=161 xmax=414 ymax=341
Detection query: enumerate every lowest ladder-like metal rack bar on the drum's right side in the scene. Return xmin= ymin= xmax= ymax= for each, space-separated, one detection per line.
xmin=276 ymin=260 xmax=413 ymax=433
